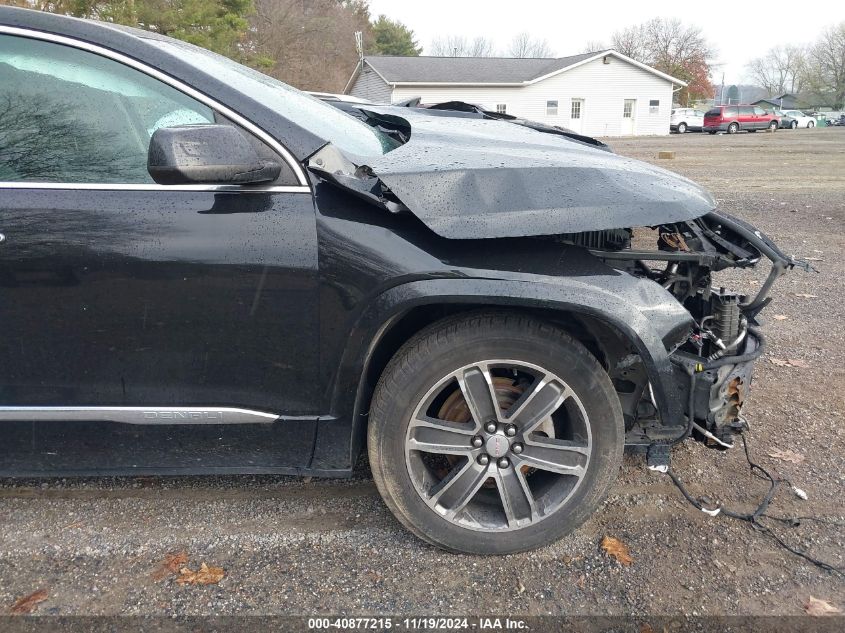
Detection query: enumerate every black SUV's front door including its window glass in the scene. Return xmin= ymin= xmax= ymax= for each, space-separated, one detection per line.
xmin=0 ymin=35 xmax=318 ymax=422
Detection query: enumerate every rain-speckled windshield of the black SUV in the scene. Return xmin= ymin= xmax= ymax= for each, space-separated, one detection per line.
xmin=147 ymin=38 xmax=400 ymax=156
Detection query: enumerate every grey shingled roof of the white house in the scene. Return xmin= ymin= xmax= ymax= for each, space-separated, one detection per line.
xmin=347 ymin=50 xmax=687 ymax=90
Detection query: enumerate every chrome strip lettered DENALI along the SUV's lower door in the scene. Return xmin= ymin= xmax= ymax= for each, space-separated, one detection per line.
xmin=0 ymin=405 xmax=280 ymax=425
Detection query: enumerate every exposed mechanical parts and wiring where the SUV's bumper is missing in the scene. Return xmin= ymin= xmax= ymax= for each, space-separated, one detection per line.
xmin=580 ymin=211 xmax=812 ymax=450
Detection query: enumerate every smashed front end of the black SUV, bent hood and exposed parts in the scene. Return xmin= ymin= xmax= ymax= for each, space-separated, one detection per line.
xmin=308 ymin=108 xmax=811 ymax=461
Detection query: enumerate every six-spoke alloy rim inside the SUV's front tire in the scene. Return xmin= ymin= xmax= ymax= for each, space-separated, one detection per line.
xmin=405 ymin=359 xmax=592 ymax=531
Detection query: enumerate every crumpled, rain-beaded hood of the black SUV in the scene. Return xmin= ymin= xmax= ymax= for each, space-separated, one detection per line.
xmin=332 ymin=108 xmax=716 ymax=239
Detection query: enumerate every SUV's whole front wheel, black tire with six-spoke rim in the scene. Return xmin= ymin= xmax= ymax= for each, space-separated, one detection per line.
xmin=368 ymin=313 xmax=625 ymax=554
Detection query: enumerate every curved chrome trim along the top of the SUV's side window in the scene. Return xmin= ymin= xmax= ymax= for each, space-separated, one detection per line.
xmin=0 ymin=24 xmax=310 ymax=188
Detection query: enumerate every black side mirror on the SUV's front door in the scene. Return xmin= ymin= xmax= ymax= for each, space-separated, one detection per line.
xmin=147 ymin=125 xmax=282 ymax=185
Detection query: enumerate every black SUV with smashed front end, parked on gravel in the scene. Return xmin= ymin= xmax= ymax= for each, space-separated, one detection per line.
xmin=0 ymin=8 xmax=795 ymax=553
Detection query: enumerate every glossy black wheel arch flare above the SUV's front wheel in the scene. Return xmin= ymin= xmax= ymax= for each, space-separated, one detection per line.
xmin=315 ymin=274 xmax=692 ymax=468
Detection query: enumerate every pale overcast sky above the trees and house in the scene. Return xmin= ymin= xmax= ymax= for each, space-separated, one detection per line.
xmin=370 ymin=0 xmax=845 ymax=83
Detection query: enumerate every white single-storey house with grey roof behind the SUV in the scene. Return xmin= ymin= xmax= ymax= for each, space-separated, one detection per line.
xmin=345 ymin=50 xmax=686 ymax=136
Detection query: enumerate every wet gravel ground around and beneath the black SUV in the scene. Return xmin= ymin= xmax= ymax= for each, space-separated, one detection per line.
xmin=0 ymin=128 xmax=845 ymax=615
